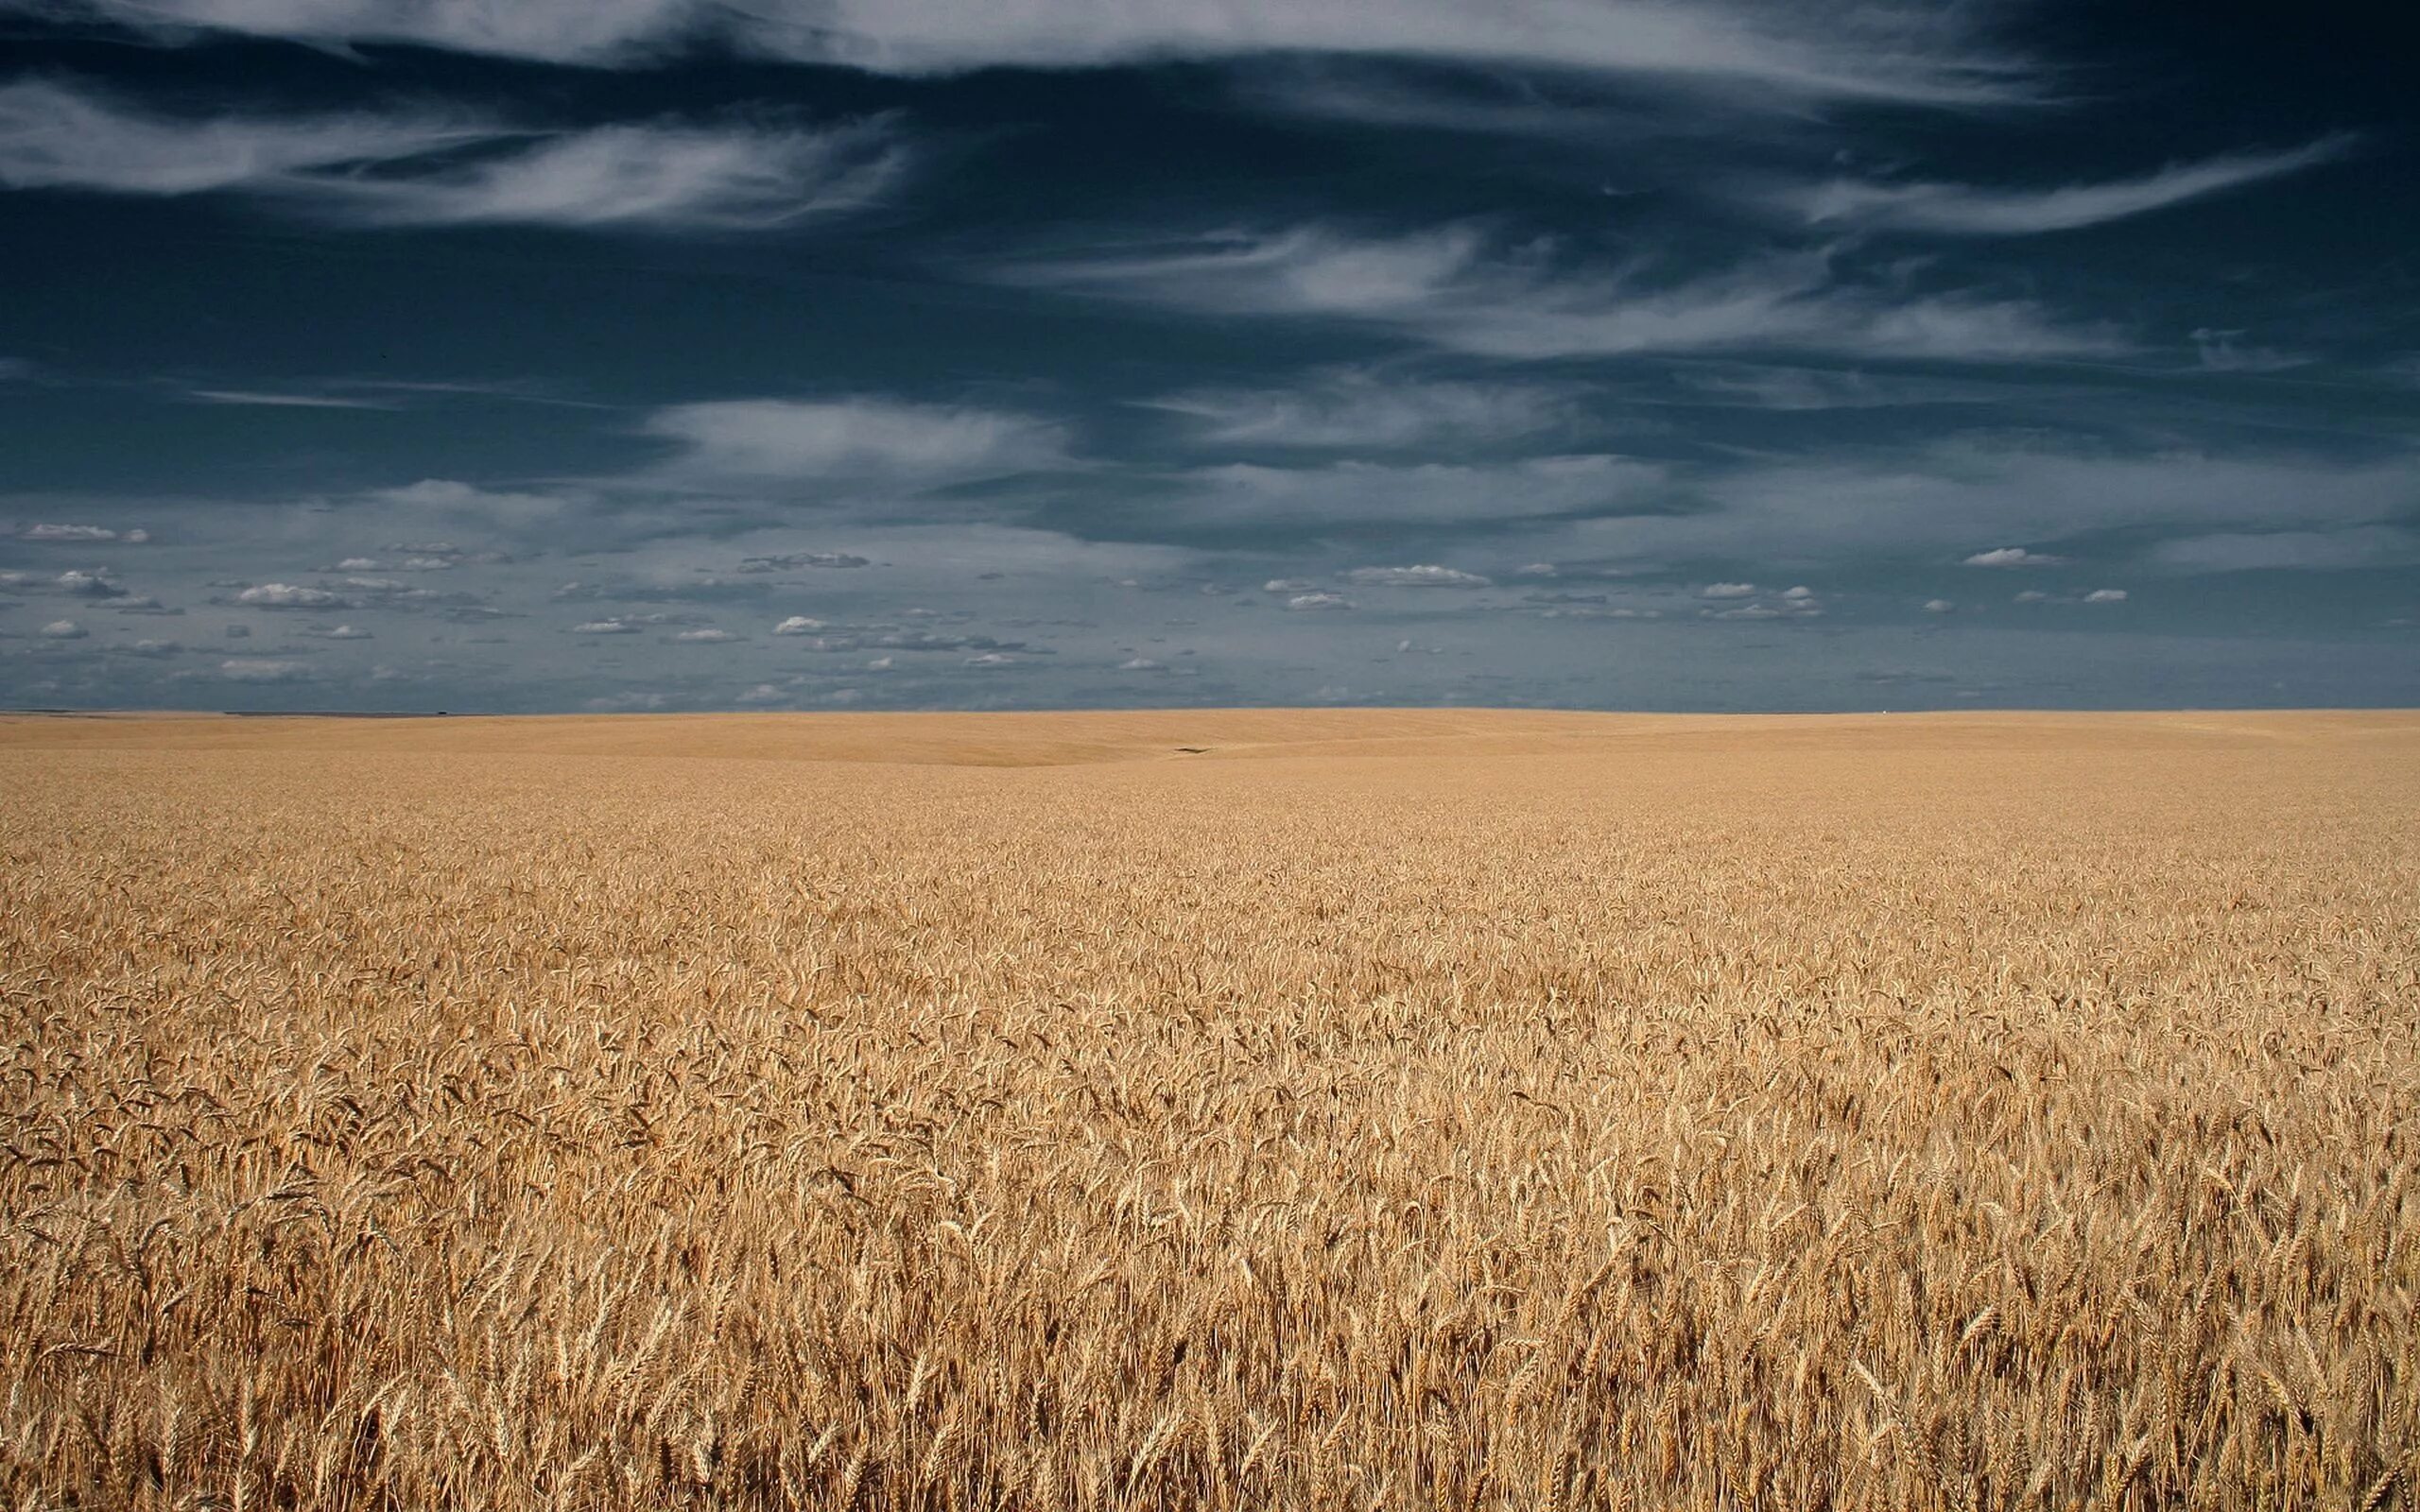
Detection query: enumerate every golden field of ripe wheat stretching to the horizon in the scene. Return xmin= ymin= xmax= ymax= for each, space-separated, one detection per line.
xmin=0 ymin=712 xmax=2420 ymax=1512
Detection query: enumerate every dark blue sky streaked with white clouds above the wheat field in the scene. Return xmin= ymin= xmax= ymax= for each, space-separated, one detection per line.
xmin=0 ymin=0 xmax=2420 ymax=713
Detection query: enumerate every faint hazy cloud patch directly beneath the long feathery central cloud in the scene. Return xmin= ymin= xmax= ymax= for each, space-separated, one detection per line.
xmin=1147 ymin=368 xmax=1573 ymax=448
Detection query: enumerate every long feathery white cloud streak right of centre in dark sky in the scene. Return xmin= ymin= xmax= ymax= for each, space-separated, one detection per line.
xmin=1011 ymin=225 xmax=2127 ymax=360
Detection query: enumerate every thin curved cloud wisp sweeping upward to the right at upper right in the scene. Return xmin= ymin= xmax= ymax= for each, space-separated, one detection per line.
xmin=1769 ymin=135 xmax=2355 ymax=237
